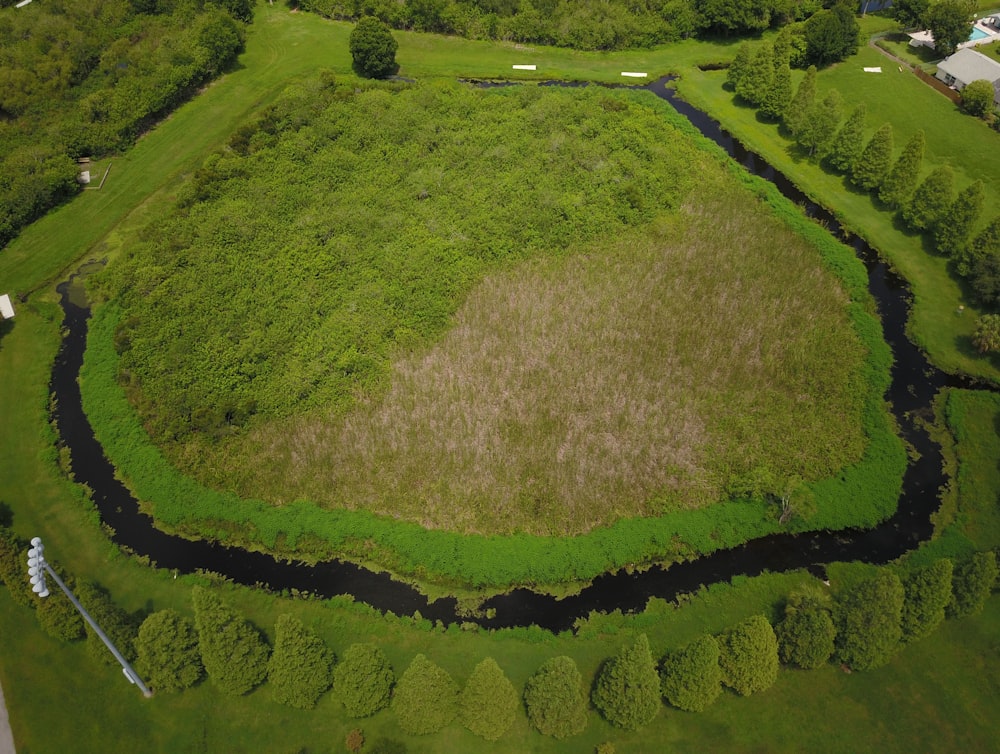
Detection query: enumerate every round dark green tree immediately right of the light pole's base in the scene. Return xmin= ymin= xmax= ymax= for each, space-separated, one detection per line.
xmin=135 ymin=609 xmax=205 ymax=693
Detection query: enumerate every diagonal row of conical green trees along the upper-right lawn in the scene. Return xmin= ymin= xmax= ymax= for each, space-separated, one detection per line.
xmin=727 ymin=43 xmax=1000 ymax=351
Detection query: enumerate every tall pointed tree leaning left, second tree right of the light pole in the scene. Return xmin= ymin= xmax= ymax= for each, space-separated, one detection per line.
xmin=192 ymin=587 xmax=269 ymax=696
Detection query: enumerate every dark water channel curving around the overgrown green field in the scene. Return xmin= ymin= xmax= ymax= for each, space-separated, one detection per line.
xmin=51 ymin=79 xmax=969 ymax=631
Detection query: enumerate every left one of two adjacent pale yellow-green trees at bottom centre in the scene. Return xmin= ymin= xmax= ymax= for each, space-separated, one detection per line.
xmin=392 ymin=654 xmax=458 ymax=736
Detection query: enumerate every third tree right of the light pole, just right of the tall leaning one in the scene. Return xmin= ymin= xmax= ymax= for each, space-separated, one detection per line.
xmin=267 ymin=614 xmax=334 ymax=709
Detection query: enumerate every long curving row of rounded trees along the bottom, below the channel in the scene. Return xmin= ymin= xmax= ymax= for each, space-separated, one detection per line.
xmin=0 ymin=529 xmax=998 ymax=741
